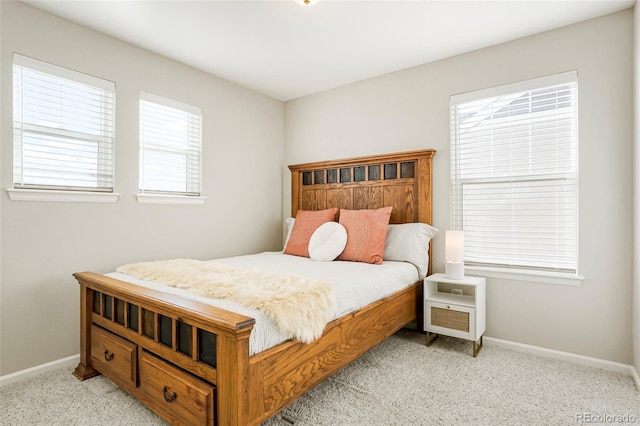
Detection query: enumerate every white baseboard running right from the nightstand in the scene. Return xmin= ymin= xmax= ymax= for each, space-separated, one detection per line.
xmin=484 ymin=337 xmax=640 ymax=384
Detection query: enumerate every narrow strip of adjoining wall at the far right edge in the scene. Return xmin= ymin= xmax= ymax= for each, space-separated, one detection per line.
xmin=633 ymin=3 xmax=640 ymax=387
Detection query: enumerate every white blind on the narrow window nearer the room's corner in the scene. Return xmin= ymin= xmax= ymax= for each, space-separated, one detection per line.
xmin=140 ymin=92 xmax=202 ymax=196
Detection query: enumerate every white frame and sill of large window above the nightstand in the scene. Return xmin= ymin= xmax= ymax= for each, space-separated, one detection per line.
xmin=450 ymin=70 xmax=584 ymax=285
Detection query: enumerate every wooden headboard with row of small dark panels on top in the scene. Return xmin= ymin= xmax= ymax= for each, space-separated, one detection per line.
xmin=289 ymin=149 xmax=436 ymax=225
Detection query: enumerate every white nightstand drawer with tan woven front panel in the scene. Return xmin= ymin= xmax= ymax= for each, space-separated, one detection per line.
xmin=425 ymin=302 xmax=475 ymax=340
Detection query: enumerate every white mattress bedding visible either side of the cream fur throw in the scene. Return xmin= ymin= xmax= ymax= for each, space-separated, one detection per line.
xmin=106 ymin=252 xmax=420 ymax=355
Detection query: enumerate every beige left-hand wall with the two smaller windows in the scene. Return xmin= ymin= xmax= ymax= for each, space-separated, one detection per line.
xmin=0 ymin=2 xmax=284 ymax=375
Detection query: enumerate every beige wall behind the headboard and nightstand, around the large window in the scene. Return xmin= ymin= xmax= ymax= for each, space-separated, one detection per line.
xmin=283 ymin=10 xmax=637 ymax=364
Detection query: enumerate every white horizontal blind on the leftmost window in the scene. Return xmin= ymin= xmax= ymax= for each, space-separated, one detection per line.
xmin=13 ymin=54 xmax=115 ymax=192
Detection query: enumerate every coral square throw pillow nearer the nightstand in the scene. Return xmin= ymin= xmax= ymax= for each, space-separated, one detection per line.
xmin=337 ymin=207 xmax=393 ymax=265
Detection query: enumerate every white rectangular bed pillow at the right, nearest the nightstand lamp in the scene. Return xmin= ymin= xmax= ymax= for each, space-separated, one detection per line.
xmin=383 ymin=223 xmax=438 ymax=278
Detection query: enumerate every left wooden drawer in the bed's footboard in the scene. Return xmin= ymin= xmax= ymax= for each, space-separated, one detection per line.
xmin=91 ymin=325 xmax=138 ymax=390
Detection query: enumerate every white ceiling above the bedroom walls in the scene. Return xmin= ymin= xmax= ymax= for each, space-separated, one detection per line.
xmin=23 ymin=0 xmax=635 ymax=101
